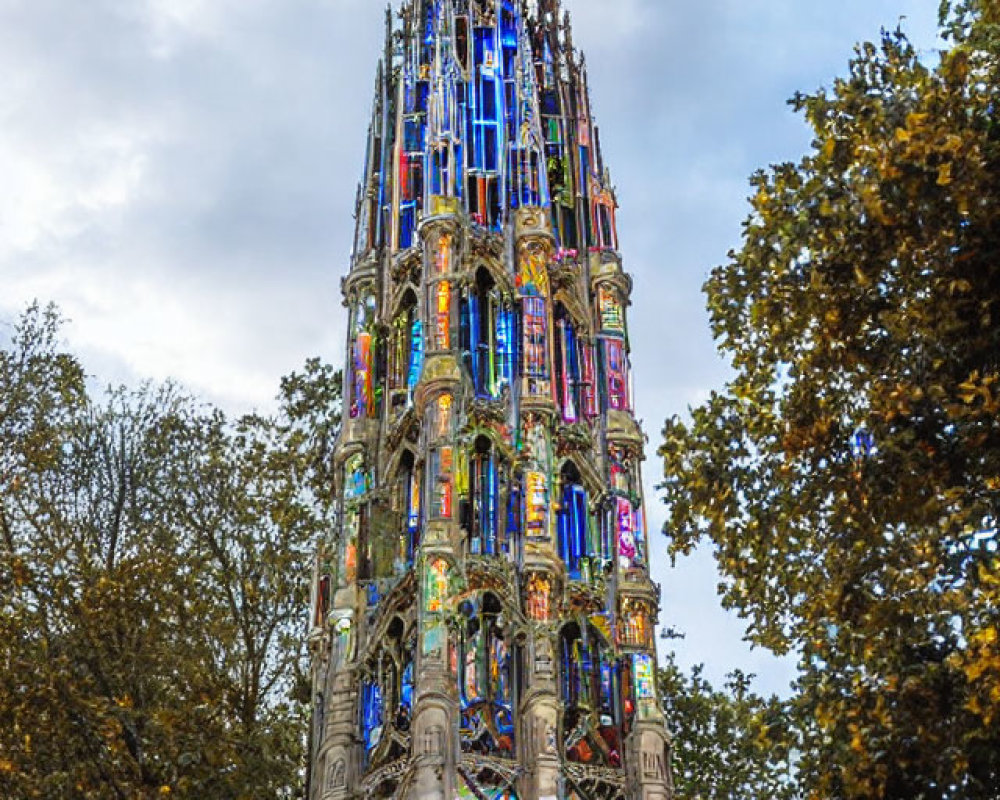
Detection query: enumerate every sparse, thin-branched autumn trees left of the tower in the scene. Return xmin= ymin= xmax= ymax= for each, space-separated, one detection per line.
xmin=0 ymin=308 xmax=339 ymax=800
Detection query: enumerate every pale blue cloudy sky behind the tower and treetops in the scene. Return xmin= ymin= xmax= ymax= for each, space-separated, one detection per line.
xmin=0 ymin=0 xmax=938 ymax=691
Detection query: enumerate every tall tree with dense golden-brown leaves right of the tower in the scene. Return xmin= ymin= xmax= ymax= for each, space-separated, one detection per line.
xmin=660 ymin=0 xmax=1000 ymax=799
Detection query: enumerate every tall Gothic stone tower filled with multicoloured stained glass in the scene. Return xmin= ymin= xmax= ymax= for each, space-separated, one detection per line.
xmin=309 ymin=0 xmax=670 ymax=800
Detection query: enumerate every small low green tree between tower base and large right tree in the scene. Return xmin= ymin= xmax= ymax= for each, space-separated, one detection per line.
xmin=658 ymin=653 xmax=797 ymax=800
